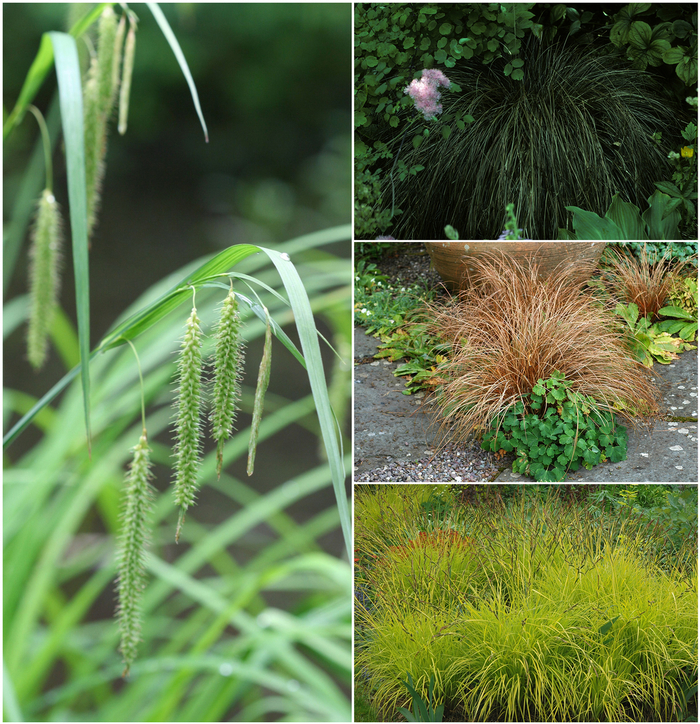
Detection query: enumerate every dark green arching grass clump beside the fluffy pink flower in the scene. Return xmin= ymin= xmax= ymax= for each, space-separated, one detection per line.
xmin=392 ymin=38 xmax=680 ymax=239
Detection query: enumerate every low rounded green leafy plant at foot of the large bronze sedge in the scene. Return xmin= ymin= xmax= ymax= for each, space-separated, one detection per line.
xmin=481 ymin=372 xmax=627 ymax=482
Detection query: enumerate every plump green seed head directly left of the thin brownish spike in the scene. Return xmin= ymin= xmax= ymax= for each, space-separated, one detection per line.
xmin=209 ymin=290 xmax=244 ymax=477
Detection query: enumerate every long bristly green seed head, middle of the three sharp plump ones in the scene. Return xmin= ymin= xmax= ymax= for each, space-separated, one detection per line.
xmin=174 ymin=307 xmax=202 ymax=541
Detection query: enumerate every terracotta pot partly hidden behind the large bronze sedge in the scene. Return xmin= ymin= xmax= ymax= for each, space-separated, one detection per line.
xmin=425 ymin=241 xmax=605 ymax=290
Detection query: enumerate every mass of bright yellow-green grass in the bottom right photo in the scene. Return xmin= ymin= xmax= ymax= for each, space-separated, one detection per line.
xmin=356 ymin=490 xmax=698 ymax=721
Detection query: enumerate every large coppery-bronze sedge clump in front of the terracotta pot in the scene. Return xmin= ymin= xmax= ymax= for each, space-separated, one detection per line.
xmin=430 ymin=254 xmax=658 ymax=441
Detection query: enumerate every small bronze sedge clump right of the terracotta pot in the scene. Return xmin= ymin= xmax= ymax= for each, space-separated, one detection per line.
xmin=608 ymin=244 xmax=687 ymax=322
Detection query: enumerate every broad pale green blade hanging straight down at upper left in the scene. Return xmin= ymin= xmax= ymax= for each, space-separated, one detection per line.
xmin=49 ymin=32 xmax=91 ymax=451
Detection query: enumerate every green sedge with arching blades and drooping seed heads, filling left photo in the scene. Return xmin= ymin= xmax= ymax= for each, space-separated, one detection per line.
xmin=3 ymin=3 xmax=351 ymax=721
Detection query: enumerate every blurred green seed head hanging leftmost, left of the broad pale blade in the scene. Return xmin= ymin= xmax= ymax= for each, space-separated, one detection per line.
xmin=27 ymin=189 xmax=63 ymax=370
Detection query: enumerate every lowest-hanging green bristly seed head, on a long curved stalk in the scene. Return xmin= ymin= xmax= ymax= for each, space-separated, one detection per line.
xmin=117 ymin=430 xmax=153 ymax=676
